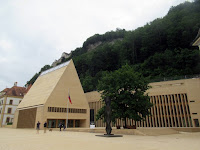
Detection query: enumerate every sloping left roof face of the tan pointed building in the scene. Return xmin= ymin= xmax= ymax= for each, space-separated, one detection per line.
xmin=18 ymin=61 xmax=70 ymax=108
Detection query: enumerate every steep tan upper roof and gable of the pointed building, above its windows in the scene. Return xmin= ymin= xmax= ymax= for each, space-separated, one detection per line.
xmin=17 ymin=60 xmax=89 ymax=110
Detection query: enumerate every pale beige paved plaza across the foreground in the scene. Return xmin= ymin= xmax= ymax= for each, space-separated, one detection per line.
xmin=0 ymin=128 xmax=200 ymax=150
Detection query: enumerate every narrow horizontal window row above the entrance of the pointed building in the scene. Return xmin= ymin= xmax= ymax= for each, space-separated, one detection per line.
xmin=48 ymin=107 xmax=87 ymax=113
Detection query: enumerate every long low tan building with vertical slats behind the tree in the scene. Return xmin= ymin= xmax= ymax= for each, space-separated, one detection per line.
xmin=86 ymin=77 xmax=200 ymax=127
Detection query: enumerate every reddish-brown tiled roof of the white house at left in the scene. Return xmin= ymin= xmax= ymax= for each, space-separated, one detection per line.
xmin=3 ymin=86 xmax=27 ymax=97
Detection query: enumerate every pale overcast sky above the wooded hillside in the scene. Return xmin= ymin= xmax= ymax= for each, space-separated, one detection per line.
xmin=0 ymin=0 xmax=192 ymax=91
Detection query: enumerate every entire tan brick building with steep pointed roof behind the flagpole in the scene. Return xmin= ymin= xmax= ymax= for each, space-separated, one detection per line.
xmin=13 ymin=60 xmax=89 ymax=128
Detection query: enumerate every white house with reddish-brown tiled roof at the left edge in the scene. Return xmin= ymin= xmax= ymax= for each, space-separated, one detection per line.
xmin=0 ymin=82 xmax=27 ymax=127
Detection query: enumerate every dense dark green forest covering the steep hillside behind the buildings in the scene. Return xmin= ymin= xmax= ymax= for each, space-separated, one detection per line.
xmin=27 ymin=0 xmax=200 ymax=92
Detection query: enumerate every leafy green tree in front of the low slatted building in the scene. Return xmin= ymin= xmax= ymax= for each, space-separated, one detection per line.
xmin=96 ymin=65 xmax=152 ymax=126
